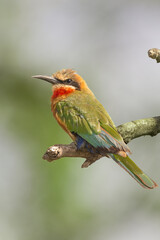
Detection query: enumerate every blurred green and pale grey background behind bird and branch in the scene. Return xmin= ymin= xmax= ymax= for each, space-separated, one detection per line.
xmin=0 ymin=0 xmax=160 ymax=240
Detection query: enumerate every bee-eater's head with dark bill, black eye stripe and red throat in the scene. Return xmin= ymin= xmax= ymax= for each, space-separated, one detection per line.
xmin=33 ymin=69 xmax=91 ymax=98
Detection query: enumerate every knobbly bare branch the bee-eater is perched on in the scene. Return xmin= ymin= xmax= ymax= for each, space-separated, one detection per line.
xmin=43 ymin=116 xmax=160 ymax=168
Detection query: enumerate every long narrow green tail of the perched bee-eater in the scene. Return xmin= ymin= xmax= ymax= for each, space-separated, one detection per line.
xmin=110 ymin=154 xmax=158 ymax=189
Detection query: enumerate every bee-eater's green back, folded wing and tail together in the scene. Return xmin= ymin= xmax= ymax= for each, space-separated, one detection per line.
xmin=56 ymin=91 xmax=157 ymax=188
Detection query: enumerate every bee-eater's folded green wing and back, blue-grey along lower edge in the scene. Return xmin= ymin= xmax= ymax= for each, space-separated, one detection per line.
xmin=56 ymin=94 xmax=129 ymax=153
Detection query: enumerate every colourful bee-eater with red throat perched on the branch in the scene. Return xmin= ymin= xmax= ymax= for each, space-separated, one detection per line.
xmin=33 ymin=69 xmax=158 ymax=189
